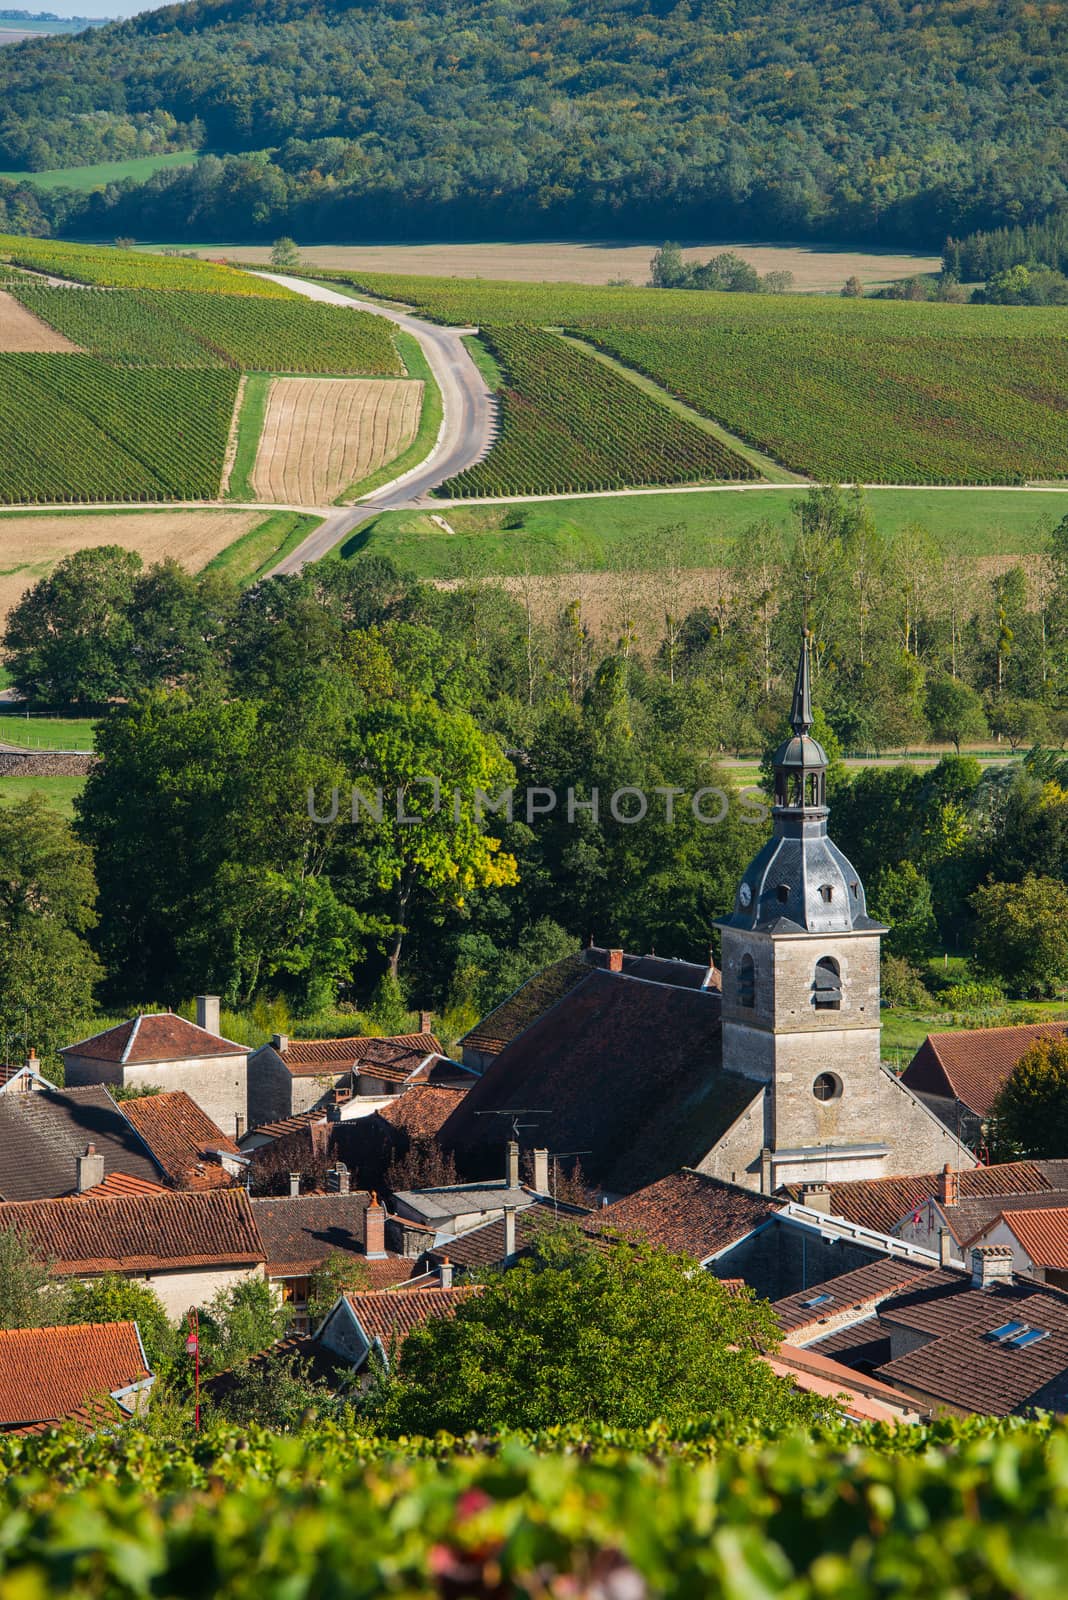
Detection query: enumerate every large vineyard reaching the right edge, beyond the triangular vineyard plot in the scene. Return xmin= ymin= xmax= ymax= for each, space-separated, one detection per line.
xmin=336 ymin=274 xmax=1068 ymax=485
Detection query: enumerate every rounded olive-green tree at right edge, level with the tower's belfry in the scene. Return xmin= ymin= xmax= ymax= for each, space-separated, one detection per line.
xmin=970 ymin=874 xmax=1068 ymax=998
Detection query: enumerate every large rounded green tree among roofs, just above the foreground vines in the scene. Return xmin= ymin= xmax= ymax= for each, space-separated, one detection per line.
xmin=370 ymin=1229 xmax=823 ymax=1434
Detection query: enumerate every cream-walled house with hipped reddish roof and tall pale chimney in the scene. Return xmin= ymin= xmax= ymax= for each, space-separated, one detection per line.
xmin=59 ymin=995 xmax=248 ymax=1139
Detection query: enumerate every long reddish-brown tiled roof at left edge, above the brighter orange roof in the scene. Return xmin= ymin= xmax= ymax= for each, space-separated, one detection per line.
xmin=0 ymin=1189 xmax=264 ymax=1277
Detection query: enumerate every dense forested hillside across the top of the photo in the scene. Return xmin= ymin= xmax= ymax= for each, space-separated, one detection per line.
xmin=0 ymin=0 xmax=1068 ymax=246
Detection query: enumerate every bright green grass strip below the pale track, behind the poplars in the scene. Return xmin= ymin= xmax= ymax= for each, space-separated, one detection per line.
xmin=348 ymin=488 xmax=1068 ymax=578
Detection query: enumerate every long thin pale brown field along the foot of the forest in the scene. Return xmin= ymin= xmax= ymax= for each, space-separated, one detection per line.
xmin=183 ymin=243 xmax=942 ymax=293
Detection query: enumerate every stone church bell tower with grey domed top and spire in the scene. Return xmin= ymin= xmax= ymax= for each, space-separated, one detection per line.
xmin=719 ymin=635 xmax=895 ymax=1186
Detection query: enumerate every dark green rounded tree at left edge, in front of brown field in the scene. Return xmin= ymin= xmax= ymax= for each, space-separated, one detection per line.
xmin=3 ymin=544 xmax=141 ymax=706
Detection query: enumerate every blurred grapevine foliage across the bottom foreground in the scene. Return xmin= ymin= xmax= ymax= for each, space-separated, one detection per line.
xmin=0 ymin=1421 xmax=1068 ymax=1600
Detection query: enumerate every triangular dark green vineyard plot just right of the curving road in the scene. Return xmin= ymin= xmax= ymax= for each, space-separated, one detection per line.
xmin=443 ymin=326 xmax=758 ymax=496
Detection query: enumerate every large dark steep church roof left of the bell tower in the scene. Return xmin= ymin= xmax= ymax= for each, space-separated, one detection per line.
xmin=440 ymin=970 xmax=748 ymax=1194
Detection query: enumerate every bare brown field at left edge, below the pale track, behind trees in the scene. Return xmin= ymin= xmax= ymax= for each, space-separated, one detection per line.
xmin=0 ymin=510 xmax=264 ymax=616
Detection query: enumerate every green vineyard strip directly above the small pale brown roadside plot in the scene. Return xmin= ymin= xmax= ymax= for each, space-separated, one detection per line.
xmin=14 ymin=283 xmax=403 ymax=378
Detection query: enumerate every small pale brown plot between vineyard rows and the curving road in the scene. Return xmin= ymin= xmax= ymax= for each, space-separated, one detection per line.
xmin=251 ymin=378 xmax=422 ymax=506
